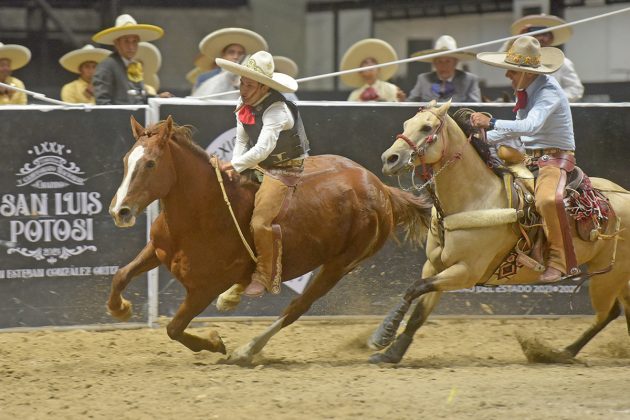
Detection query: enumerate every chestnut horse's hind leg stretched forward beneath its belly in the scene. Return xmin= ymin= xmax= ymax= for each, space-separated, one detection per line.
xmin=228 ymin=263 xmax=356 ymax=365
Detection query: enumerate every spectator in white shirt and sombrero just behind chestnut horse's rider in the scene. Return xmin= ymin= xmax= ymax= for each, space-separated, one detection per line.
xmin=192 ymin=28 xmax=269 ymax=99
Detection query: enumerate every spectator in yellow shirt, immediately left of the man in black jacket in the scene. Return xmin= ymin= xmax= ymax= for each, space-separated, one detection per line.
xmin=59 ymin=44 xmax=111 ymax=104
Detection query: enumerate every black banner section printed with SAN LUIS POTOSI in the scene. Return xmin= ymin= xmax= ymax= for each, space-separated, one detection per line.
xmin=0 ymin=108 xmax=148 ymax=328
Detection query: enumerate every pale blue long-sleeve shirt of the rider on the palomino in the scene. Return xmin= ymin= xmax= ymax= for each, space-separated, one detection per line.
xmin=487 ymin=74 xmax=575 ymax=150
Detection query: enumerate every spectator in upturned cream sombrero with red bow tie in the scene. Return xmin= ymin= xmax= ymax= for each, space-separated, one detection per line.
xmin=340 ymin=38 xmax=405 ymax=102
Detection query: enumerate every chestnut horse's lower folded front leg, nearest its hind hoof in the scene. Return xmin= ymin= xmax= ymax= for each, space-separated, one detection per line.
xmin=166 ymin=289 xmax=225 ymax=354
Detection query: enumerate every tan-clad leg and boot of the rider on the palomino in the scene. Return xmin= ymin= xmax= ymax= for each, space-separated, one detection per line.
xmin=534 ymin=166 xmax=567 ymax=274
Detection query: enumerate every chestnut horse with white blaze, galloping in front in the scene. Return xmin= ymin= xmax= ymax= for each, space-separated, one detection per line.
xmin=107 ymin=117 xmax=431 ymax=363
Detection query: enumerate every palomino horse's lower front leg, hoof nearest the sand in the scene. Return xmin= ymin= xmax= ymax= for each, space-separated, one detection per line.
xmin=368 ymin=292 xmax=442 ymax=363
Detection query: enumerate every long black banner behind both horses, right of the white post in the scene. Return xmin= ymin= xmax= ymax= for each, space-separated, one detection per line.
xmin=151 ymin=103 xmax=630 ymax=316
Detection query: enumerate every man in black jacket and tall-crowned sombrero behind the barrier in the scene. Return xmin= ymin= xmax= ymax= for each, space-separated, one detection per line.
xmin=92 ymin=15 xmax=171 ymax=105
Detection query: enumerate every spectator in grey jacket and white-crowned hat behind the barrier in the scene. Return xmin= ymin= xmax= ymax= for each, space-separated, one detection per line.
xmin=407 ymin=35 xmax=481 ymax=102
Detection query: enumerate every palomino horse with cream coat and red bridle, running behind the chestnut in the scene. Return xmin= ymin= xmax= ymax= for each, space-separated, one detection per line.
xmin=368 ymin=102 xmax=630 ymax=363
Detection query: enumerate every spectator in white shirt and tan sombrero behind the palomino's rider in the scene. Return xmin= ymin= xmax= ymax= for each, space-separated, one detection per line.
xmin=511 ymin=15 xmax=584 ymax=102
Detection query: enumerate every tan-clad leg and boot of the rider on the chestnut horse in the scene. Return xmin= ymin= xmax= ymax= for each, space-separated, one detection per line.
xmin=251 ymin=175 xmax=290 ymax=293
